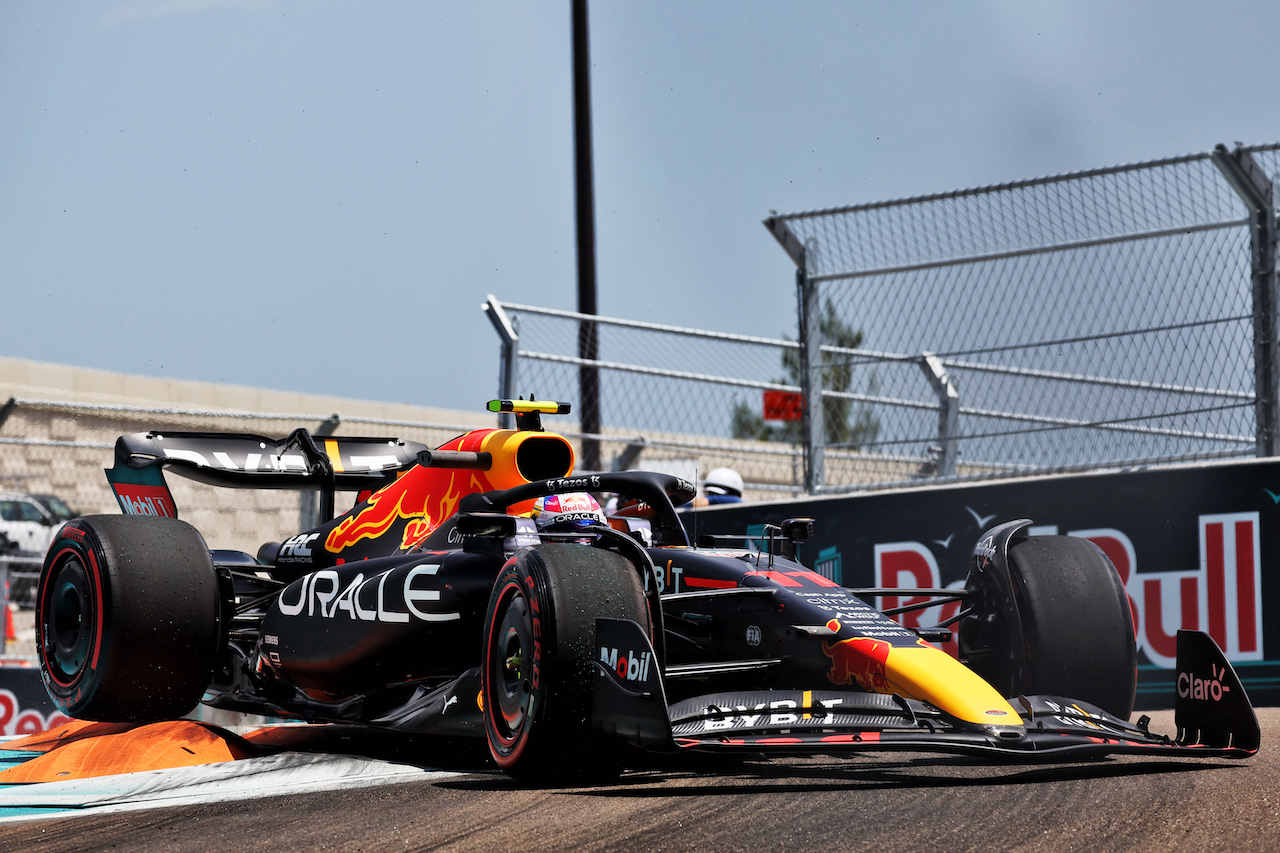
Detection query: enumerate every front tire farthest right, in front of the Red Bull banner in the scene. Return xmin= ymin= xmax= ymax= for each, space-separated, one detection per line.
xmin=960 ymin=537 xmax=1138 ymax=720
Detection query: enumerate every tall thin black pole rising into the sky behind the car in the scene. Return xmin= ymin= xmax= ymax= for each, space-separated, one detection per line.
xmin=573 ymin=0 xmax=600 ymax=471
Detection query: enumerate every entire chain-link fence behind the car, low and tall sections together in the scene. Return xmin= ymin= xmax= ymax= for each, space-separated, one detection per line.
xmin=488 ymin=145 xmax=1280 ymax=492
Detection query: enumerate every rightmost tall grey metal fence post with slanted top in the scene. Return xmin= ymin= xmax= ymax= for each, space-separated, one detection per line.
xmin=1210 ymin=145 xmax=1280 ymax=456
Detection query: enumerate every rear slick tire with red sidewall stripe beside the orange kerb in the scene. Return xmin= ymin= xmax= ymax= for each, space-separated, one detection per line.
xmin=36 ymin=515 xmax=219 ymax=722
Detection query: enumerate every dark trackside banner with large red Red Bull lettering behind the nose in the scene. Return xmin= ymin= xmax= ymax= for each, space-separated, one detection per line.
xmin=687 ymin=460 xmax=1280 ymax=708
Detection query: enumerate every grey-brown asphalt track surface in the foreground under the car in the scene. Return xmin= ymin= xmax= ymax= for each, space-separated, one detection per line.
xmin=0 ymin=708 xmax=1280 ymax=853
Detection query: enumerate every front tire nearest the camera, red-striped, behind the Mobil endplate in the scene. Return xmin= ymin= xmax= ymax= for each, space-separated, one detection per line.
xmin=481 ymin=544 xmax=652 ymax=785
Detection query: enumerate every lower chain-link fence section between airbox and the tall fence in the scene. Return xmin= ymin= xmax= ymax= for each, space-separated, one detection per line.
xmin=485 ymin=296 xmax=804 ymax=500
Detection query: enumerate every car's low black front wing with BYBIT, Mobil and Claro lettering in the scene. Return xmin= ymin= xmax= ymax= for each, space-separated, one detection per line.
xmin=594 ymin=619 xmax=1260 ymax=761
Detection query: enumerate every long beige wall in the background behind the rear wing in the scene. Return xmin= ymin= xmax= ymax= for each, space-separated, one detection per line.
xmin=0 ymin=359 xmax=495 ymax=552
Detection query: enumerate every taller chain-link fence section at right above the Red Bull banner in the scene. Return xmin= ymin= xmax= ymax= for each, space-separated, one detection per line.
xmin=767 ymin=146 xmax=1277 ymax=489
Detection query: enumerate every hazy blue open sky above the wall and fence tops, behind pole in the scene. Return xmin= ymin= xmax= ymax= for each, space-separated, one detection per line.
xmin=0 ymin=0 xmax=1280 ymax=409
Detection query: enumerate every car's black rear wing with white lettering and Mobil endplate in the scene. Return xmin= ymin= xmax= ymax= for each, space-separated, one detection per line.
xmin=106 ymin=429 xmax=440 ymax=517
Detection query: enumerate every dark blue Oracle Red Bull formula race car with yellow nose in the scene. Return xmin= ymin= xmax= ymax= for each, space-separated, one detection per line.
xmin=37 ymin=400 xmax=1260 ymax=784
